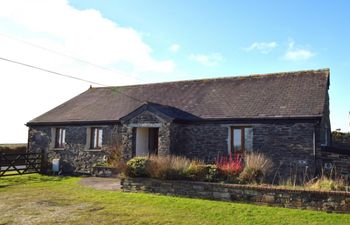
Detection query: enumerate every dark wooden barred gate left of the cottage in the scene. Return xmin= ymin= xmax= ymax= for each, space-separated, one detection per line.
xmin=0 ymin=150 xmax=44 ymax=177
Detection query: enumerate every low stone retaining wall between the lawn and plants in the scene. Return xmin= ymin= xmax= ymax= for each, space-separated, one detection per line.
xmin=122 ymin=178 xmax=350 ymax=212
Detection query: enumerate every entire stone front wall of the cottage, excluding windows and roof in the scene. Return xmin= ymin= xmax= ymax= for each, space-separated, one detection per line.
xmin=29 ymin=116 xmax=326 ymax=180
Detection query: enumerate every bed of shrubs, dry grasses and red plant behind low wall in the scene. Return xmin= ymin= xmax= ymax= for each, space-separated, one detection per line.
xmin=126 ymin=154 xmax=271 ymax=183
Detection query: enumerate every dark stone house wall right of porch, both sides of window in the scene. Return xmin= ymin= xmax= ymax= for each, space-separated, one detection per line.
xmin=171 ymin=120 xmax=320 ymax=179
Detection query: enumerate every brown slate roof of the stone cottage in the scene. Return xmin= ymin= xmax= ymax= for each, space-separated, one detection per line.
xmin=28 ymin=69 xmax=329 ymax=125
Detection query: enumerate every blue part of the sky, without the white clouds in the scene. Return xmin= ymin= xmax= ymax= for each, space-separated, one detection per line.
xmin=70 ymin=0 xmax=350 ymax=130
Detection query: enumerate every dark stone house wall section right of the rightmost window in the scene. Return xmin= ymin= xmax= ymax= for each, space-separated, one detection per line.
xmin=253 ymin=123 xmax=320 ymax=181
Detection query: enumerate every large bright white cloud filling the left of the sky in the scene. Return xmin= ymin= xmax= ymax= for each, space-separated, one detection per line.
xmin=0 ymin=0 xmax=175 ymax=143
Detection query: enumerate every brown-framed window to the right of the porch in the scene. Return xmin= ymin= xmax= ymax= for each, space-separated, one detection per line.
xmin=230 ymin=127 xmax=253 ymax=154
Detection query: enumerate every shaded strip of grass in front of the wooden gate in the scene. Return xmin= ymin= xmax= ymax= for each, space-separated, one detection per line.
xmin=0 ymin=174 xmax=70 ymax=188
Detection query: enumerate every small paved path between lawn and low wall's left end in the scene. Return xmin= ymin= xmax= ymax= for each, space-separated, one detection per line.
xmin=78 ymin=177 xmax=121 ymax=191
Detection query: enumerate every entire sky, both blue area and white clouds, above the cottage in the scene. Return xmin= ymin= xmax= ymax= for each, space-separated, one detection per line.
xmin=0 ymin=0 xmax=350 ymax=143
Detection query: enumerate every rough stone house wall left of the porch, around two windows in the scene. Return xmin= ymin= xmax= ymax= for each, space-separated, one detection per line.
xmin=28 ymin=125 xmax=121 ymax=173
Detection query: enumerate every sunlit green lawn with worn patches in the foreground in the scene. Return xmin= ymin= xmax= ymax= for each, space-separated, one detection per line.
xmin=0 ymin=175 xmax=350 ymax=225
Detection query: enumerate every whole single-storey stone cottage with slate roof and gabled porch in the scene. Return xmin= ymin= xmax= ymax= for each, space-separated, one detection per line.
xmin=27 ymin=69 xmax=330 ymax=176
